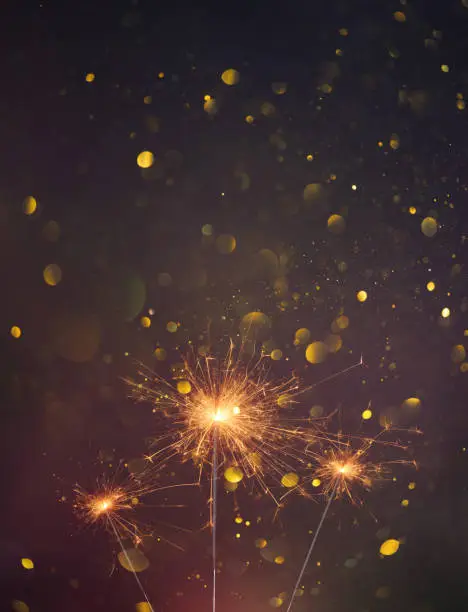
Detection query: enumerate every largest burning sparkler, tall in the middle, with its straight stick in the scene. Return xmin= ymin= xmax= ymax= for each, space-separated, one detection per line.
xmin=128 ymin=344 xmax=309 ymax=612
